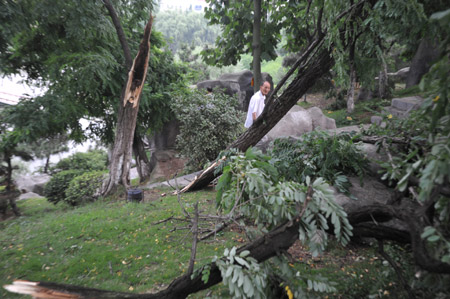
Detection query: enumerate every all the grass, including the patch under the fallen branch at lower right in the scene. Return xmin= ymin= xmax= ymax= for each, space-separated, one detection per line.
xmin=0 ymin=189 xmax=412 ymax=298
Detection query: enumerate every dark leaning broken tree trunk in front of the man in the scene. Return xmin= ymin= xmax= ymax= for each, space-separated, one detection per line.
xmin=181 ymin=49 xmax=334 ymax=192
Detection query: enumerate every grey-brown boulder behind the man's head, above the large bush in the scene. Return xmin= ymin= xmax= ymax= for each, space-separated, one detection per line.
xmin=197 ymin=70 xmax=273 ymax=111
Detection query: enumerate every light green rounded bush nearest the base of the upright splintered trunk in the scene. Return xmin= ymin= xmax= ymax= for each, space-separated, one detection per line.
xmin=64 ymin=171 xmax=105 ymax=206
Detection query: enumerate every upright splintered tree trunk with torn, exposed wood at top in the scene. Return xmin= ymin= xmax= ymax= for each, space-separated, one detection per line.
xmin=102 ymin=17 xmax=153 ymax=194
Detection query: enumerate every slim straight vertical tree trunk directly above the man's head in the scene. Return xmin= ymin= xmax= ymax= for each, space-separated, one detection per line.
xmin=252 ymin=0 xmax=262 ymax=92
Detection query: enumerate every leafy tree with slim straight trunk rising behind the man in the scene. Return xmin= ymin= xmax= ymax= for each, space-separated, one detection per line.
xmin=202 ymin=0 xmax=281 ymax=91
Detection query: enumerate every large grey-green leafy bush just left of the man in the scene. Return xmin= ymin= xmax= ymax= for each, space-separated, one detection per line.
xmin=172 ymin=90 xmax=243 ymax=170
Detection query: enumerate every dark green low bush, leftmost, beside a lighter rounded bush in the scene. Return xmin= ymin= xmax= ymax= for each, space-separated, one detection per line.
xmin=44 ymin=169 xmax=83 ymax=204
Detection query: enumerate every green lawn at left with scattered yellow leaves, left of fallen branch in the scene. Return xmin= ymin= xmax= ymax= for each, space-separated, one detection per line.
xmin=0 ymin=191 xmax=241 ymax=298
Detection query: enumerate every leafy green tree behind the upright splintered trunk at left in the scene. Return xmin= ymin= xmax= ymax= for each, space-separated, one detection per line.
xmin=0 ymin=0 xmax=184 ymax=185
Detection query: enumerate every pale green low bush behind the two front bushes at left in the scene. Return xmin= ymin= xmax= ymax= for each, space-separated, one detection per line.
xmin=52 ymin=150 xmax=108 ymax=173
